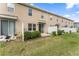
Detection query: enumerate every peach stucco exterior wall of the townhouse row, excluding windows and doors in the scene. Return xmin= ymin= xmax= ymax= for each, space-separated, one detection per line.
xmin=0 ymin=3 xmax=73 ymax=33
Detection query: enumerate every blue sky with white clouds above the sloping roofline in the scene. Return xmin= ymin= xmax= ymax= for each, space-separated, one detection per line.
xmin=31 ymin=3 xmax=79 ymax=22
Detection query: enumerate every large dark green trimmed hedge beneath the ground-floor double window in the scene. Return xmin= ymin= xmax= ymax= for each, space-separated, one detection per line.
xmin=24 ymin=31 xmax=41 ymax=40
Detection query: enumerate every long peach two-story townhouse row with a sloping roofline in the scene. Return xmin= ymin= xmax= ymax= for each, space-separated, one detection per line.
xmin=0 ymin=3 xmax=74 ymax=36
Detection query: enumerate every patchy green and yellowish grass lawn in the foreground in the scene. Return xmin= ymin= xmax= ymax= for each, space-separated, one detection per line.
xmin=0 ymin=33 xmax=79 ymax=56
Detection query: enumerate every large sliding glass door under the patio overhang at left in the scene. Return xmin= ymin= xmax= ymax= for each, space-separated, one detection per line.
xmin=1 ymin=20 xmax=15 ymax=36
